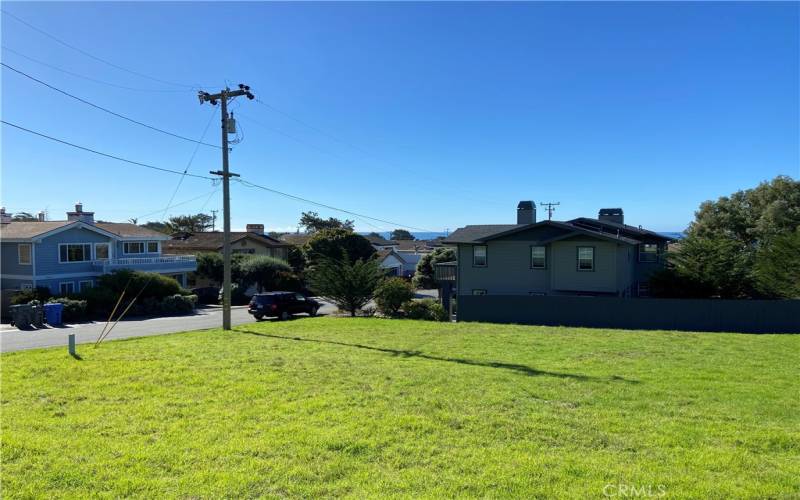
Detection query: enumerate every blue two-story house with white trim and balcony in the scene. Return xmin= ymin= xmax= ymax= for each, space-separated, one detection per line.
xmin=0 ymin=203 xmax=197 ymax=295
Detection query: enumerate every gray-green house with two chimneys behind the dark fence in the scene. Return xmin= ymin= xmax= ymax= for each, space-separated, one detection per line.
xmin=444 ymin=201 xmax=671 ymax=297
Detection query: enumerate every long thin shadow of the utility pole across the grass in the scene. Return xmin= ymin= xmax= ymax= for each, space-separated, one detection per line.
xmin=234 ymin=328 xmax=640 ymax=384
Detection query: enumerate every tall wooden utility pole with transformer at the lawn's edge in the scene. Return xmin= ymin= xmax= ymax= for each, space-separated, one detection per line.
xmin=197 ymin=83 xmax=255 ymax=330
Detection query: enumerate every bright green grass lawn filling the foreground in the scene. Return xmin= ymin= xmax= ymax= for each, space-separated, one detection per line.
xmin=0 ymin=318 xmax=800 ymax=498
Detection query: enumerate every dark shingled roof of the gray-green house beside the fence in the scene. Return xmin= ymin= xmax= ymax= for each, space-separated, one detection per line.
xmin=445 ymin=219 xmax=652 ymax=245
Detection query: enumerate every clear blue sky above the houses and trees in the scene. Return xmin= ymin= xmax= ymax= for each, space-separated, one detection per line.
xmin=2 ymin=2 xmax=800 ymax=231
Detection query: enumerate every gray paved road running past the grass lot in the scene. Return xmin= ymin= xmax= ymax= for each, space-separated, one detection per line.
xmin=0 ymin=290 xmax=438 ymax=352
